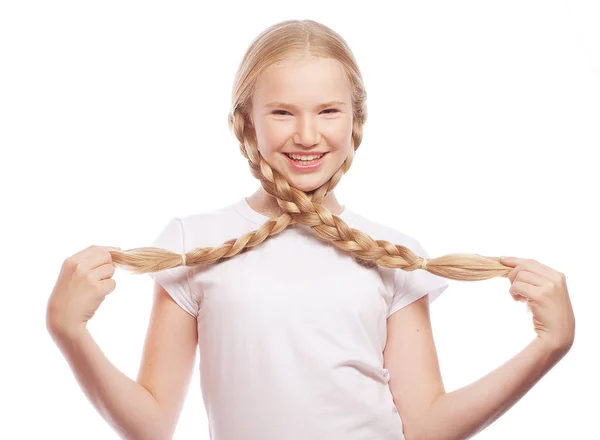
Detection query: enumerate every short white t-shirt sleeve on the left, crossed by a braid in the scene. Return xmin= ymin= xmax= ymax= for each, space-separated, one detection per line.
xmin=148 ymin=217 xmax=198 ymax=319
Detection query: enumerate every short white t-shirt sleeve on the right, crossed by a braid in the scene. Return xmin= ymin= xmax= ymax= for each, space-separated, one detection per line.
xmin=387 ymin=239 xmax=448 ymax=318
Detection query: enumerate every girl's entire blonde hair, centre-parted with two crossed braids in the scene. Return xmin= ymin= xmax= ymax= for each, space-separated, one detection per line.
xmin=110 ymin=20 xmax=511 ymax=281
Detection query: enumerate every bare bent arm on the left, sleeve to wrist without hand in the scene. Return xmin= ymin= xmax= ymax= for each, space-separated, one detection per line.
xmin=48 ymin=284 xmax=197 ymax=440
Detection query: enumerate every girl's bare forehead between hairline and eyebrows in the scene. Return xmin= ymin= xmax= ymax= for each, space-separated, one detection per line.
xmin=253 ymin=57 xmax=350 ymax=106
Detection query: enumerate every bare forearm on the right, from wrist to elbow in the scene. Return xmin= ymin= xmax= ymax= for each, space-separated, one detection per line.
xmin=419 ymin=338 xmax=568 ymax=440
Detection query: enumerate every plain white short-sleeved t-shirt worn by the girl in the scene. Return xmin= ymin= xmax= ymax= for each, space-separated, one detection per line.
xmin=149 ymin=198 xmax=448 ymax=440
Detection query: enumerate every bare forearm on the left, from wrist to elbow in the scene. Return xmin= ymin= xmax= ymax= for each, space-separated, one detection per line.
xmin=50 ymin=328 xmax=170 ymax=440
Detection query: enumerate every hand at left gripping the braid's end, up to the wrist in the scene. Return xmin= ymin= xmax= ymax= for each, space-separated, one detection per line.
xmin=46 ymin=246 xmax=121 ymax=334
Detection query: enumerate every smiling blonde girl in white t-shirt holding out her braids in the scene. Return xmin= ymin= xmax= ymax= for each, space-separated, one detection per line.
xmin=48 ymin=20 xmax=574 ymax=440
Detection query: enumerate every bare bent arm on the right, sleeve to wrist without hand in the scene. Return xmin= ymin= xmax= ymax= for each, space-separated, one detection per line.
xmin=384 ymin=295 xmax=568 ymax=440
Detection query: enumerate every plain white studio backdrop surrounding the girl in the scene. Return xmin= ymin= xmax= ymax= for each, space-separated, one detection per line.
xmin=0 ymin=0 xmax=600 ymax=440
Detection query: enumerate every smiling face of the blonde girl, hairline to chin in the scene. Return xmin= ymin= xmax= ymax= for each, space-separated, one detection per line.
xmin=252 ymin=57 xmax=352 ymax=192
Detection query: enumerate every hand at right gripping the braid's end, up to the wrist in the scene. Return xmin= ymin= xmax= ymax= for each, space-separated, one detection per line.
xmin=500 ymin=257 xmax=575 ymax=351
